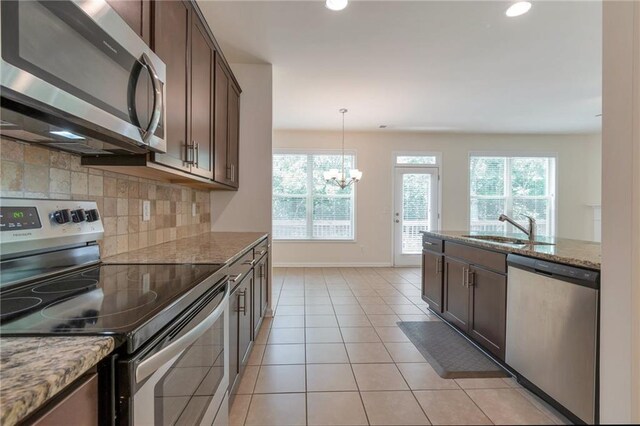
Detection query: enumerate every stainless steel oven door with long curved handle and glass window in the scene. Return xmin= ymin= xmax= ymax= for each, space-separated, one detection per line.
xmin=118 ymin=281 xmax=229 ymax=425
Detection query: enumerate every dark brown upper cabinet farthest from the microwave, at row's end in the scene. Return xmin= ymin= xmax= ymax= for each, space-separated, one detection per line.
xmin=214 ymin=55 xmax=240 ymax=188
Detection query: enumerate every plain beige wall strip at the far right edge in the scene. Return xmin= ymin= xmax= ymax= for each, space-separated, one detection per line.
xmin=600 ymin=1 xmax=640 ymax=424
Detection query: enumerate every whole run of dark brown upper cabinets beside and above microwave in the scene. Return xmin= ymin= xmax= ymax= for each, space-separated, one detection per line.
xmin=82 ymin=0 xmax=241 ymax=190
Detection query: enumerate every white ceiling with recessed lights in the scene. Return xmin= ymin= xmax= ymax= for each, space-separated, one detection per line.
xmin=200 ymin=1 xmax=602 ymax=133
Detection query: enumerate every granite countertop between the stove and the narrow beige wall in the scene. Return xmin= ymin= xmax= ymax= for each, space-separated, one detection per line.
xmin=102 ymin=232 xmax=269 ymax=263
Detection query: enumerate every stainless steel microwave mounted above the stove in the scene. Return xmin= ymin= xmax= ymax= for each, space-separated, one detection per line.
xmin=0 ymin=0 xmax=166 ymax=154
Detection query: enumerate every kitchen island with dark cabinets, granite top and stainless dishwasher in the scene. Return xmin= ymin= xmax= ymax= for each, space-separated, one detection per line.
xmin=422 ymin=231 xmax=600 ymax=424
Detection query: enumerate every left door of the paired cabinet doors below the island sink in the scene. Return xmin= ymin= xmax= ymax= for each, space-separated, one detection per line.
xmin=443 ymin=257 xmax=469 ymax=331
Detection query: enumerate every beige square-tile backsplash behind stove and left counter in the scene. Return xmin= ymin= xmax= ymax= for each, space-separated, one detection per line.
xmin=0 ymin=139 xmax=211 ymax=257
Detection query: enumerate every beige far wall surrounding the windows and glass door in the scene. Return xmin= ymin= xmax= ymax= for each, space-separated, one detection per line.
xmin=273 ymin=130 xmax=601 ymax=265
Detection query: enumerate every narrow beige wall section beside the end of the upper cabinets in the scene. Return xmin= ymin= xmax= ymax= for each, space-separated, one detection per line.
xmin=211 ymin=64 xmax=272 ymax=232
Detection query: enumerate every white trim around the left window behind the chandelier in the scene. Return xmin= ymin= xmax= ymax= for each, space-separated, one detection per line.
xmin=271 ymin=148 xmax=358 ymax=244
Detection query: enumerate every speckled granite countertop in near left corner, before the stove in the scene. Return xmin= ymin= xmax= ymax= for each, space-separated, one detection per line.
xmin=0 ymin=337 xmax=114 ymax=426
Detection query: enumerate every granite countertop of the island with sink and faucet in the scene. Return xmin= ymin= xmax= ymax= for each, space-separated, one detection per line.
xmin=423 ymin=231 xmax=601 ymax=270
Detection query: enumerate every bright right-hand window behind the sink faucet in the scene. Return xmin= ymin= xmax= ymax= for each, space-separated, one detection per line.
xmin=469 ymin=154 xmax=556 ymax=235
